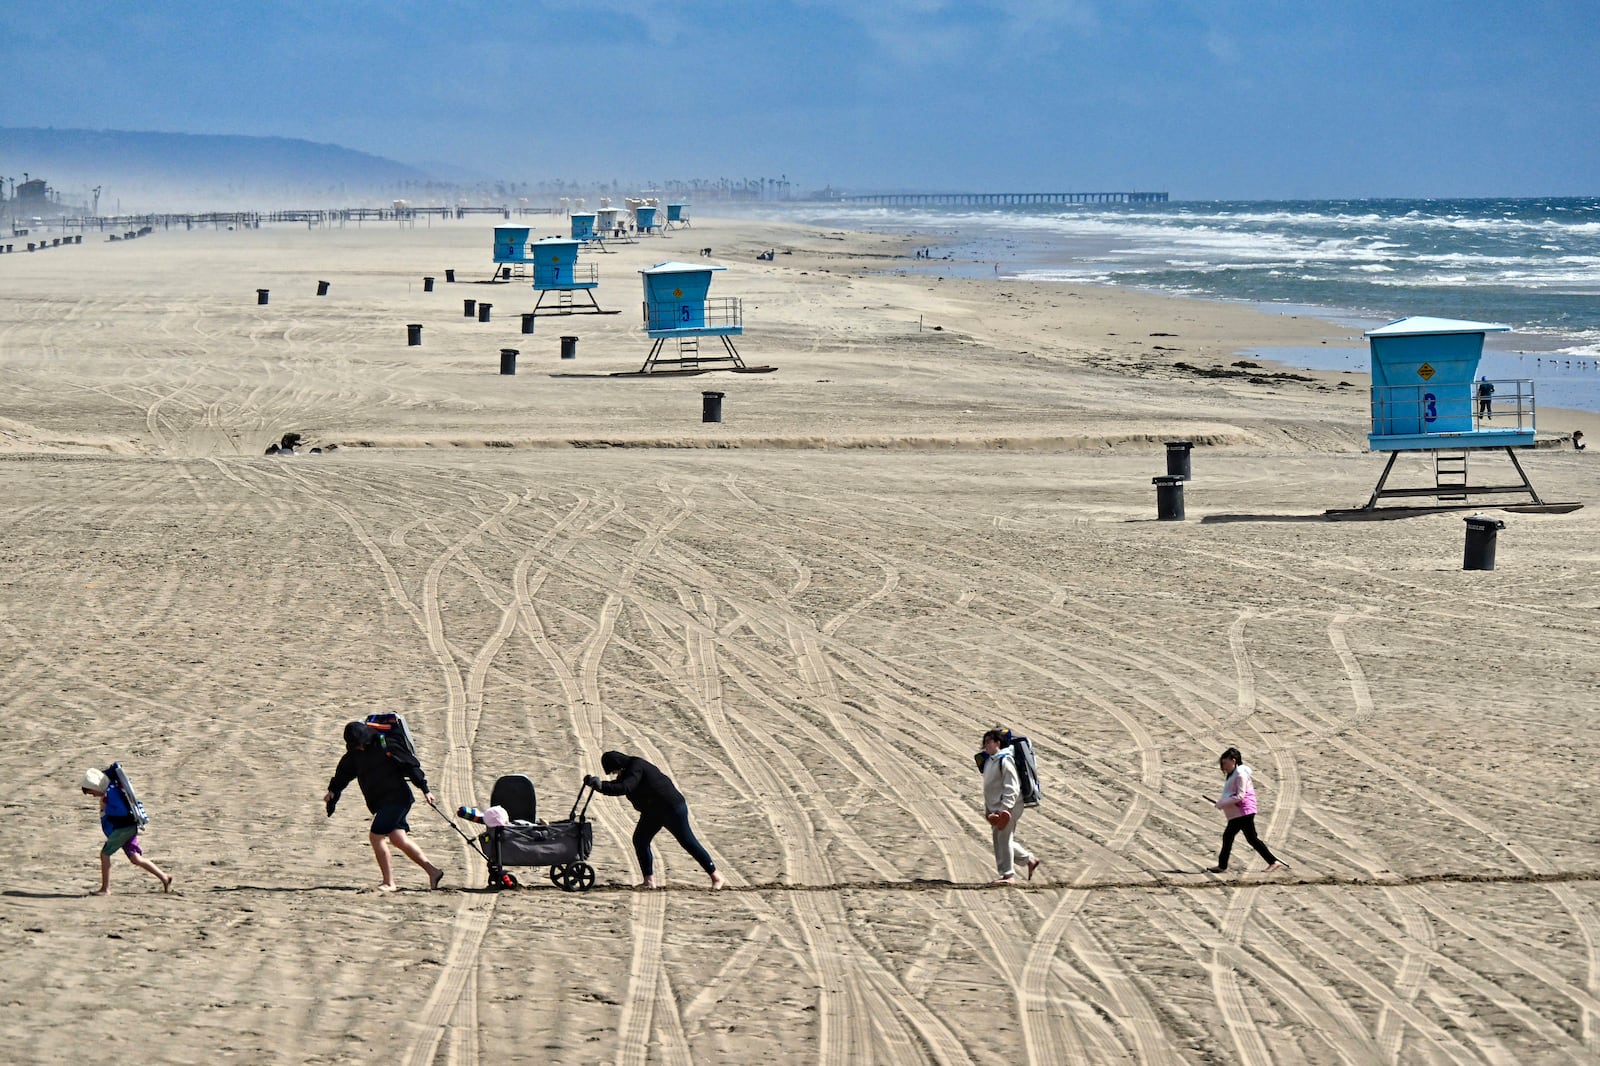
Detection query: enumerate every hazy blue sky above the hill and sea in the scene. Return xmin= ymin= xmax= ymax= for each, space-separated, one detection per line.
xmin=0 ymin=0 xmax=1600 ymax=198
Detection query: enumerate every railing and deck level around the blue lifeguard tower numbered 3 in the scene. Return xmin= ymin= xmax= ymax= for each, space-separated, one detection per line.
xmin=1368 ymin=378 xmax=1534 ymax=451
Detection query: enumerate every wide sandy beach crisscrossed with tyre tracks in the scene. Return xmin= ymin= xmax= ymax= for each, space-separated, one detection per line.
xmin=0 ymin=218 xmax=1600 ymax=1066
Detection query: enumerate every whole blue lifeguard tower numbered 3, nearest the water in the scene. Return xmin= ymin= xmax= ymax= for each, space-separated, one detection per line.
xmin=1328 ymin=317 xmax=1581 ymax=517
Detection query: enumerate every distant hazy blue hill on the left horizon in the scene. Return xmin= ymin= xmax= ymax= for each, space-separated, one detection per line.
xmin=0 ymin=126 xmax=432 ymax=213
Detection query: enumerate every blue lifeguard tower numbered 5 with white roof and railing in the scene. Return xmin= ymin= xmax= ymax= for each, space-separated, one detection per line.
xmin=640 ymin=262 xmax=755 ymax=375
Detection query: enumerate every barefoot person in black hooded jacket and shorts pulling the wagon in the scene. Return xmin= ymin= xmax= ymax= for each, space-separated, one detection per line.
xmin=322 ymin=715 xmax=445 ymax=892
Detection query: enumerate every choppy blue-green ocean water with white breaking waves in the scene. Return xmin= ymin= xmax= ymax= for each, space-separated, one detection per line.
xmin=758 ymin=197 xmax=1600 ymax=410
